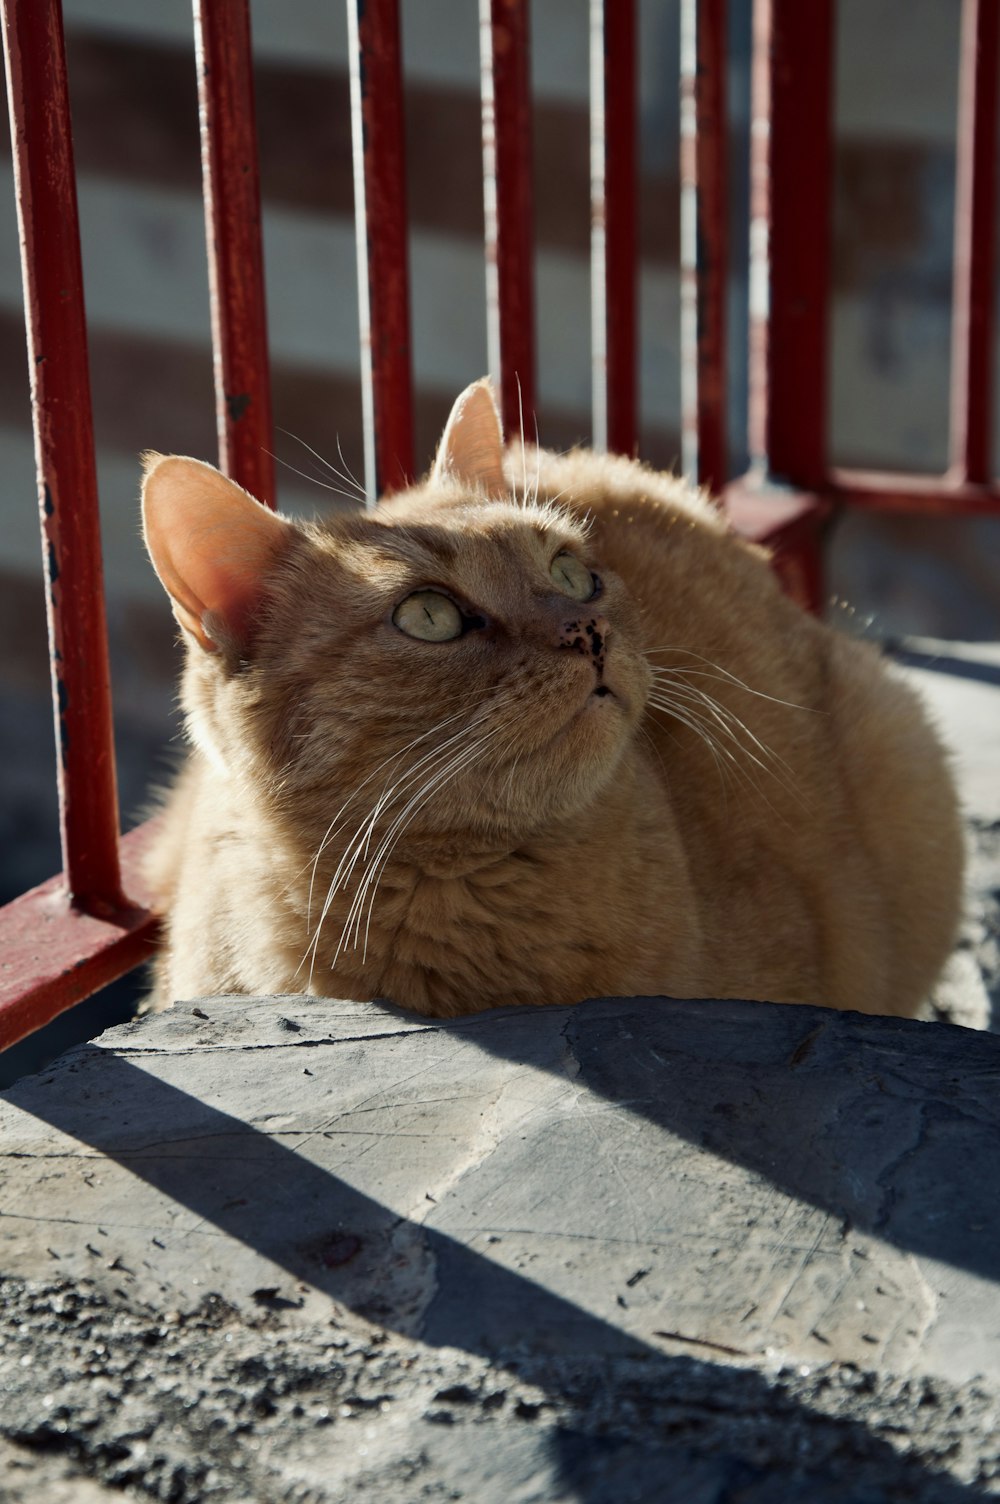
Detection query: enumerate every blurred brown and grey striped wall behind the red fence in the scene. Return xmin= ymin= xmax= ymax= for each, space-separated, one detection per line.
xmin=0 ymin=0 xmax=1000 ymax=1082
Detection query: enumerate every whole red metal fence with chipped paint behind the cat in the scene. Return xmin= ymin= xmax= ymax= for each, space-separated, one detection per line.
xmin=0 ymin=0 xmax=1000 ymax=1047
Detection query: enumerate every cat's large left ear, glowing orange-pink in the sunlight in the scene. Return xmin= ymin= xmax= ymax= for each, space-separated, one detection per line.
xmin=143 ymin=454 xmax=292 ymax=653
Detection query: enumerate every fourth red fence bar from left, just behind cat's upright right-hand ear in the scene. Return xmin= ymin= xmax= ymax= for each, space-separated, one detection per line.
xmin=480 ymin=0 xmax=535 ymax=433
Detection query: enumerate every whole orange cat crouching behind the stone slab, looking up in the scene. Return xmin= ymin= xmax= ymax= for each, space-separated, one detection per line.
xmin=143 ymin=382 xmax=962 ymax=1015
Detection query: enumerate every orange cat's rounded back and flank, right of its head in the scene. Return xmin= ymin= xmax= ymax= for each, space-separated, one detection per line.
xmin=523 ymin=439 xmax=964 ymax=1014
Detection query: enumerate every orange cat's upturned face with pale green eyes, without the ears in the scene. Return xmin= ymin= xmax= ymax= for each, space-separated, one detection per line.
xmin=269 ymin=502 xmax=650 ymax=833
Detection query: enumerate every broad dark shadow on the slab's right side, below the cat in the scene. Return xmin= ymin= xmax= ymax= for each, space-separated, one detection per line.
xmin=444 ymin=999 xmax=1000 ymax=1293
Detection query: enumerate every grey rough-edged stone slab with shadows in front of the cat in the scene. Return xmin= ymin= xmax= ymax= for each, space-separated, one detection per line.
xmin=0 ymin=999 xmax=1000 ymax=1504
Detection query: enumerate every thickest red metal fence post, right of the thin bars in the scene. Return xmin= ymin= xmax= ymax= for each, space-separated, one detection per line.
xmin=749 ymin=0 xmax=833 ymax=489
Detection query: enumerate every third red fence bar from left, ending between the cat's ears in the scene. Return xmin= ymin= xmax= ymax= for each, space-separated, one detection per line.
xmin=347 ymin=0 xmax=414 ymax=502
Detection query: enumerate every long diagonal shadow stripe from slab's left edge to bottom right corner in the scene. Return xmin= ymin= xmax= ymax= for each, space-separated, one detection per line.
xmin=0 ymin=1022 xmax=985 ymax=1504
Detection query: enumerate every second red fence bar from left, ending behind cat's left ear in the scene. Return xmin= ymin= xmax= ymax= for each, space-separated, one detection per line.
xmin=194 ymin=0 xmax=275 ymax=505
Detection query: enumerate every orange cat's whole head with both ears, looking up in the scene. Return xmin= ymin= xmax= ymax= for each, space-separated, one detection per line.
xmin=143 ymin=382 xmax=650 ymax=841
